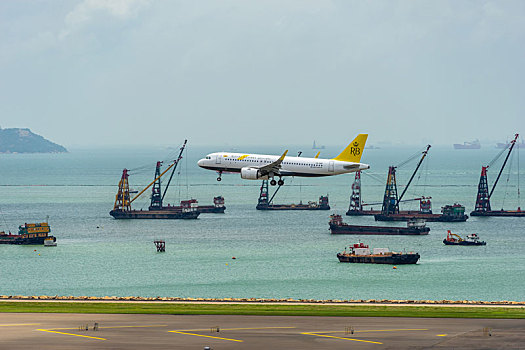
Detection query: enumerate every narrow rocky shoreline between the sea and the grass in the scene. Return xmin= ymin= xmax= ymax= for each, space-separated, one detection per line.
xmin=0 ymin=295 xmax=525 ymax=308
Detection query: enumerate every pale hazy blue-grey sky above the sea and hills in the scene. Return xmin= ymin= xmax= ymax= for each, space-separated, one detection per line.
xmin=0 ymin=0 xmax=525 ymax=147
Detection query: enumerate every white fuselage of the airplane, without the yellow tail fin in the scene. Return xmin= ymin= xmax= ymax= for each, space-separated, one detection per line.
xmin=197 ymin=152 xmax=370 ymax=180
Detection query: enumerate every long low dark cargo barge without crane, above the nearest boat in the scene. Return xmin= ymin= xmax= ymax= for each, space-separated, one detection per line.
xmin=329 ymin=214 xmax=430 ymax=236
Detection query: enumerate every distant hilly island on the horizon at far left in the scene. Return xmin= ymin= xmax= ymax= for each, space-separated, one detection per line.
xmin=0 ymin=128 xmax=67 ymax=153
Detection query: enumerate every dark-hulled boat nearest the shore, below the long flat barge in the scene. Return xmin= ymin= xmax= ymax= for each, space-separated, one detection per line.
xmin=337 ymin=243 xmax=420 ymax=265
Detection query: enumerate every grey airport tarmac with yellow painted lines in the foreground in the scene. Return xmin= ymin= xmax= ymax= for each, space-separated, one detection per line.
xmin=0 ymin=313 xmax=525 ymax=350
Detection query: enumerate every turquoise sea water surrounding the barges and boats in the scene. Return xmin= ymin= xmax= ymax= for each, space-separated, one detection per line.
xmin=0 ymin=147 xmax=525 ymax=301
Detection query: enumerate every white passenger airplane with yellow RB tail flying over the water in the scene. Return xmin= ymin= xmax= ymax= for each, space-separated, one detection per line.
xmin=197 ymin=134 xmax=370 ymax=186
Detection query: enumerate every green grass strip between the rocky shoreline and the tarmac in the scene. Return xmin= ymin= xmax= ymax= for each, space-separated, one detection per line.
xmin=0 ymin=302 xmax=525 ymax=319
